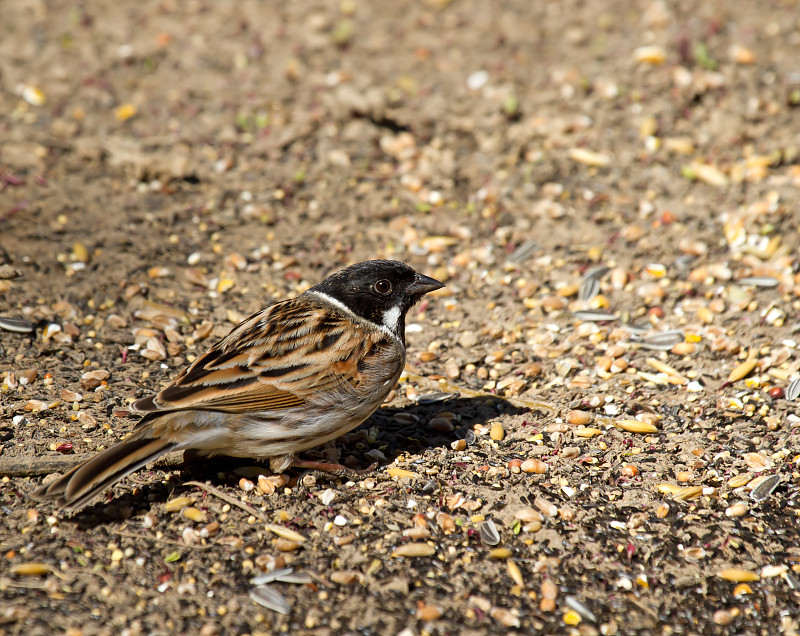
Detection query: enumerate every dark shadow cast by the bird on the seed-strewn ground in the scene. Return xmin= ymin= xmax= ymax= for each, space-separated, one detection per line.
xmin=70 ymin=394 xmax=529 ymax=529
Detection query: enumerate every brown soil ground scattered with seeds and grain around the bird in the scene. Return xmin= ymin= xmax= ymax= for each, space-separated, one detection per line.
xmin=0 ymin=0 xmax=800 ymax=635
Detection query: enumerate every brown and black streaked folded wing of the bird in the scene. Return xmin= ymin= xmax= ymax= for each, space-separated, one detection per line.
xmin=133 ymin=296 xmax=386 ymax=413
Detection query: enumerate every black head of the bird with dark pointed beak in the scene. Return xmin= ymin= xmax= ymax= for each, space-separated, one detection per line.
xmin=309 ymin=261 xmax=444 ymax=341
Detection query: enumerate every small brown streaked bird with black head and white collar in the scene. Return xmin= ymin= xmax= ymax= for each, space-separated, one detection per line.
xmin=31 ymin=260 xmax=444 ymax=512
